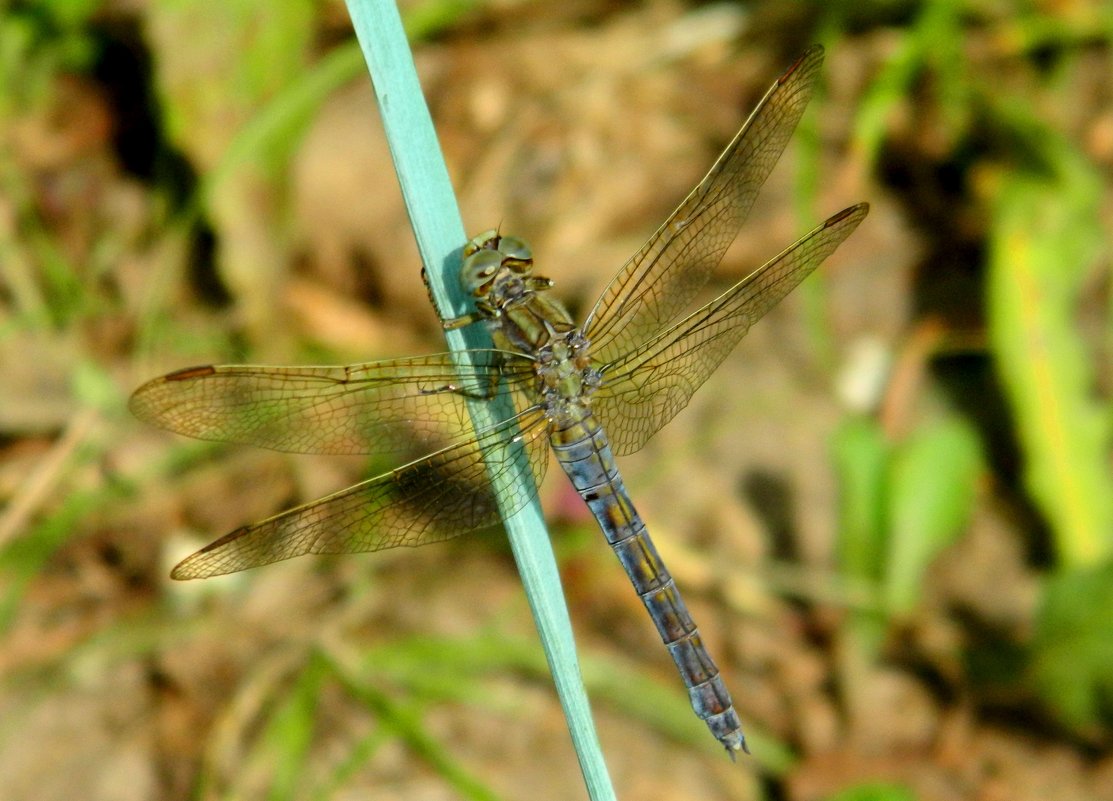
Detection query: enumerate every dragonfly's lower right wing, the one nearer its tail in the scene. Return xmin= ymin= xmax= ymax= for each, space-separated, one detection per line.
xmin=592 ymin=204 xmax=869 ymax=455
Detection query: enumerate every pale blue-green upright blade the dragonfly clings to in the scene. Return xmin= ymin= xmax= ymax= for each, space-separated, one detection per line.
xmin=347 ymin=0 xmax=614 ymax=787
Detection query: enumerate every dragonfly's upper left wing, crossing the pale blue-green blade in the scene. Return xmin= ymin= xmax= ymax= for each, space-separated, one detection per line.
xmin=129 ymin=350 xmax=531 ymax=457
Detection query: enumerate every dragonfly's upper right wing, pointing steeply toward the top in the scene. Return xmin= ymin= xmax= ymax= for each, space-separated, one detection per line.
xmin=584 ymin=46 xmax=824 ymax=363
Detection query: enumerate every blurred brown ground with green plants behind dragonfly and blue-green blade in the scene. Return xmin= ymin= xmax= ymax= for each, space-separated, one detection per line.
xmin=0 ymin=0 xmax=1113 ymax=801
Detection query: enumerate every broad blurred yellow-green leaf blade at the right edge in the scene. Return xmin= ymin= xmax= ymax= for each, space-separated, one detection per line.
xmin=988 ymin=174 xmax=1113 ymax=567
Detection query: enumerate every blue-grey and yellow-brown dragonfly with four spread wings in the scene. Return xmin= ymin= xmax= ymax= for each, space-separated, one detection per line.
xmin=130 ymin=46 xmax=868 ymax=759
